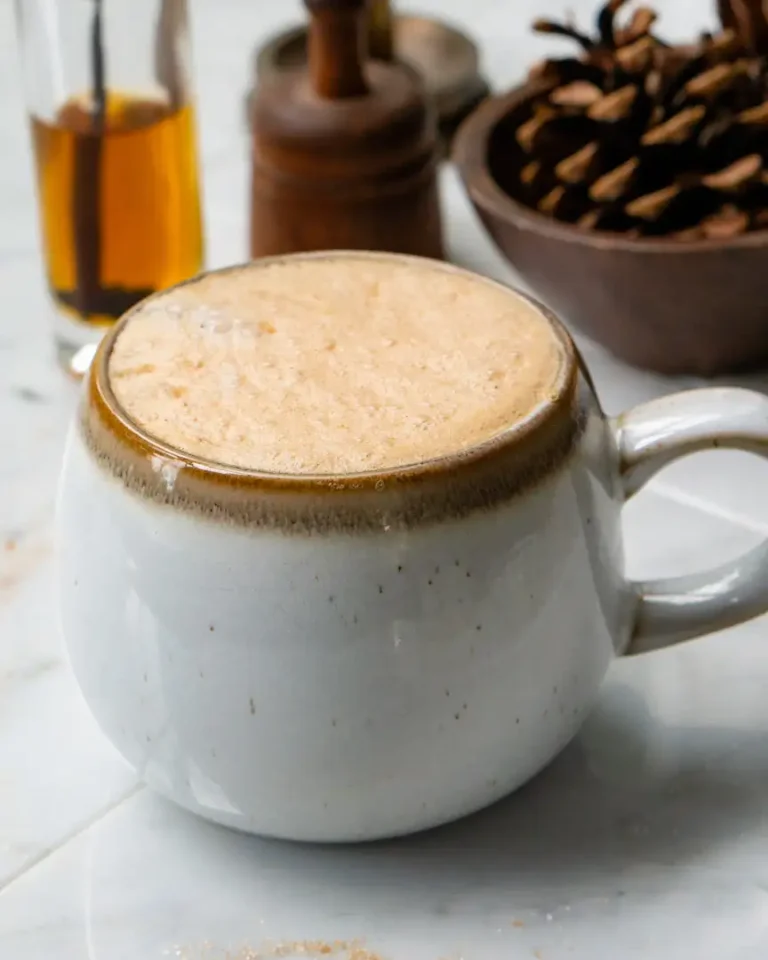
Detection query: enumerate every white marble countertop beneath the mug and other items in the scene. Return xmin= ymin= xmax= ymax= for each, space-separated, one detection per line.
xmin=0 ymin=0 xmax=768 ymax=960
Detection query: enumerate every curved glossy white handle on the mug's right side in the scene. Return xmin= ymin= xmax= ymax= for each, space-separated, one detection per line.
xmin=611 ymin=388 xmax=768 ymax=655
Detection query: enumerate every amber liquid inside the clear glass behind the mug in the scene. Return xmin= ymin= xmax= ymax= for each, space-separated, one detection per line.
xmin=32 ymin=93 xmax=203 ymax=325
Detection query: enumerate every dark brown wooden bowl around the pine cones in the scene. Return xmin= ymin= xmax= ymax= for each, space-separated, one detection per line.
xmin=453 ymin=86 xmax=768 ymax=376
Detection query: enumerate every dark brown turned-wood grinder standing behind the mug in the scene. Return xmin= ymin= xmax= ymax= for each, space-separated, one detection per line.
xmin=251 ymin=0 xmax=443 ymax=258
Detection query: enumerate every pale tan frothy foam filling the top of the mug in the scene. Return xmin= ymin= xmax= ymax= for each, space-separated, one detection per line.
xmin=109 ymin=254 xmax=564 ymax=474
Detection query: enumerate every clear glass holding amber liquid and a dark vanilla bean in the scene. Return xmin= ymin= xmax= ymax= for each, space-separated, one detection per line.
xmin=16 ymin=0 xmax=203 ymax=374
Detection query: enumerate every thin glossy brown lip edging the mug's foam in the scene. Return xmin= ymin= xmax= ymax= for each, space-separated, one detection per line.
xmin=84 ymin=250 xmax=578 ymax=493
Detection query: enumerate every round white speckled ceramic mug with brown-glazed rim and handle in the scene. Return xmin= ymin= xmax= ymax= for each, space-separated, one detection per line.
xmin=58 ymin=255 xmax=768 ymax=841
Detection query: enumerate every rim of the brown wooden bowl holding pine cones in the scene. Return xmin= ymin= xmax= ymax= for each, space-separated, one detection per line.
xmin=452 ymin=83 xmax=768 ymax=257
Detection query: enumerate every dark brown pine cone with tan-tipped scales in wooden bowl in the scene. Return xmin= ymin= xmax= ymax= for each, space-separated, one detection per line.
xmin=494 ymin=0 xmax=768 ymax=240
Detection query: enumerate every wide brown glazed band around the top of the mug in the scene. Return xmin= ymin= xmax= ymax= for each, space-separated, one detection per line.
xmin=81 ymin=251 xmax=581 ymax=530
